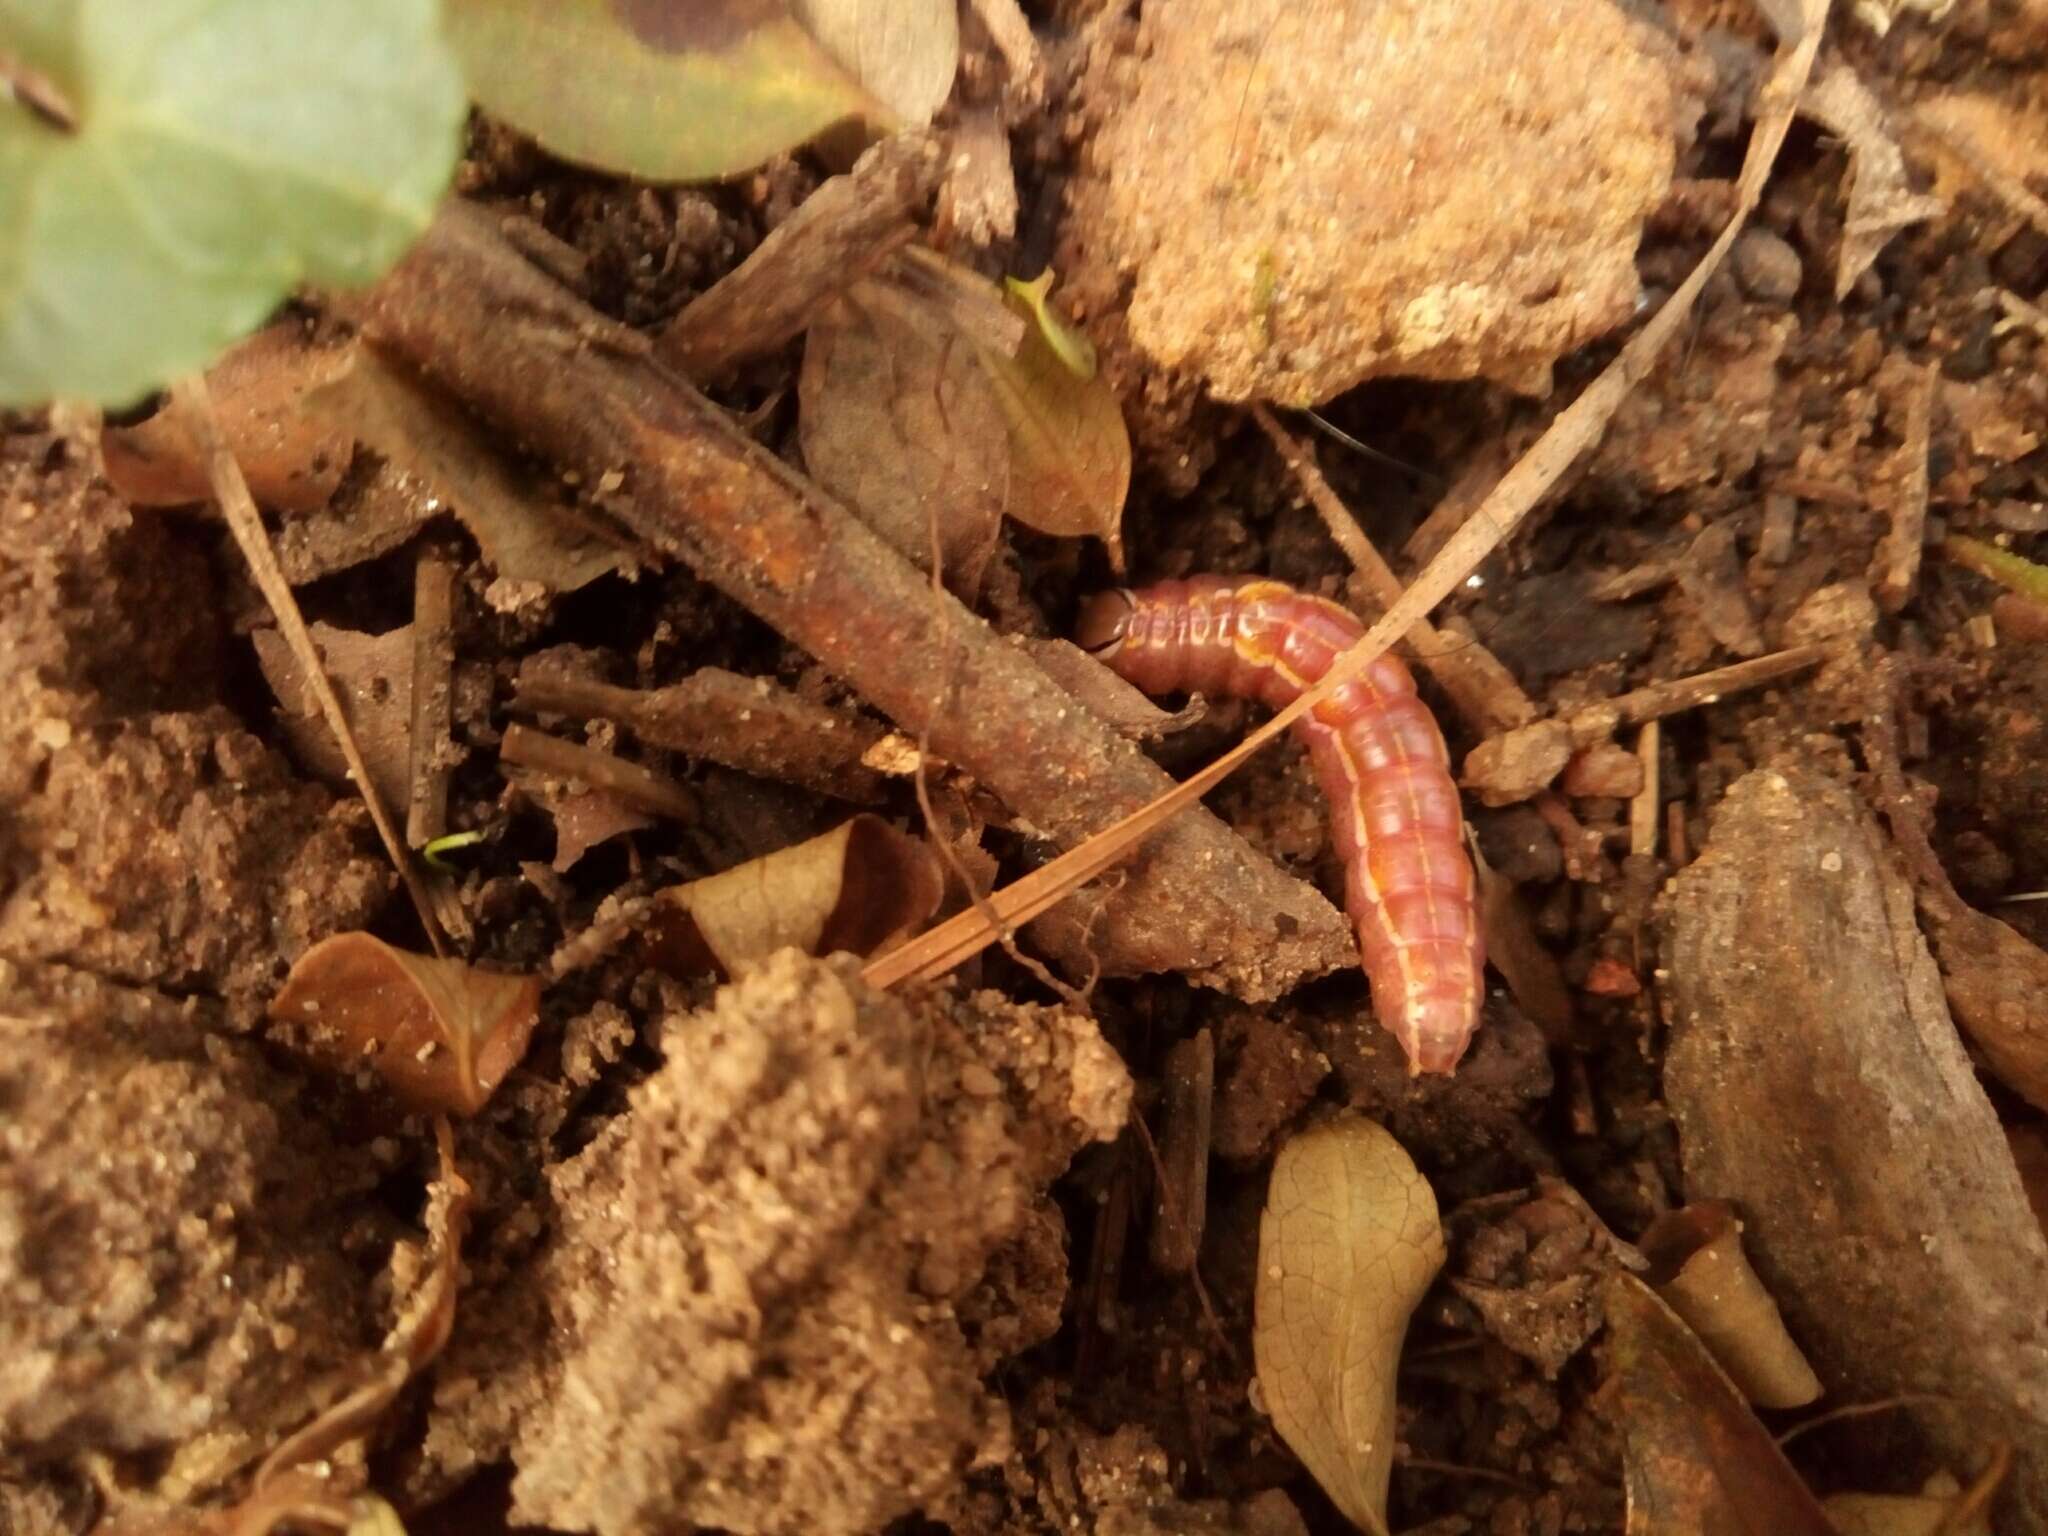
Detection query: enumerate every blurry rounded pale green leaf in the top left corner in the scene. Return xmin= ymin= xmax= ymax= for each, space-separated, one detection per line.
xmin=0 ymin=0 xmax=465 ymax=403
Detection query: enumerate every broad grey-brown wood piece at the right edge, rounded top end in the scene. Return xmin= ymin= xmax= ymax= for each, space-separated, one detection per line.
xmin=1665 ymin=770 xmax=2048 ymax=1536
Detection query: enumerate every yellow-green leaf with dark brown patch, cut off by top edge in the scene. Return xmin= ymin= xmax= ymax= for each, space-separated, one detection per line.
xmin=449 ymin=0 xmax=961 ymax=180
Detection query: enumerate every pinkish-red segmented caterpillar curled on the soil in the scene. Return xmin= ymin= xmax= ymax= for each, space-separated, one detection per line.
xmin=1075 ymin=575 xmax=1485 ymax=1073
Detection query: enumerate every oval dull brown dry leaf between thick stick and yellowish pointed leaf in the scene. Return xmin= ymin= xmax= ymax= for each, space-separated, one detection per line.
xmin=797 ymin=281 xmax=1010 ymax=602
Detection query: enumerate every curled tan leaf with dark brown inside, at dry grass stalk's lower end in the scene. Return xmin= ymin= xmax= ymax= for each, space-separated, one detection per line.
xmin=647 ymin=815 xmax=946 ymax=977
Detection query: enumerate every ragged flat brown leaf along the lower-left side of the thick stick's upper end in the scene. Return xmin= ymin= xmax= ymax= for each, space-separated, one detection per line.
xmin=305 ymin=346 xmax=633 ymax=592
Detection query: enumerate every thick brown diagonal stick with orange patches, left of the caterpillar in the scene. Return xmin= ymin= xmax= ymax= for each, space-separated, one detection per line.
xmin=360 ymin=205 xmax=1356 ymax=1001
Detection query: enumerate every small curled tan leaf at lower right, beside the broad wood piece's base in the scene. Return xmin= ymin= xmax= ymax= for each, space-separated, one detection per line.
xmin=1642 ymin=1200 xmax=1821 ymax=1409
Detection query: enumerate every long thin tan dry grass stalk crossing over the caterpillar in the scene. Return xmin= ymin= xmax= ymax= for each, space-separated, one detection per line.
xmin=862 ymin=0 xmax=1827 ymax=987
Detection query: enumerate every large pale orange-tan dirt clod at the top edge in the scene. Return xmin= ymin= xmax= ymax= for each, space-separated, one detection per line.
xmin=1075 ymin=0 xmax=1677 ymax=403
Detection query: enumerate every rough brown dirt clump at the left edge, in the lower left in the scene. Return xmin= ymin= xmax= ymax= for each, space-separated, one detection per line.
xmin=0 ymin=961 xmax=377 ymax=1487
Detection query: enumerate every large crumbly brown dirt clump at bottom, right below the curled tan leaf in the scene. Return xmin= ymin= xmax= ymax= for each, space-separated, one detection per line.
xmin=409 ymin=952 xmax=1130 ymax=1532
